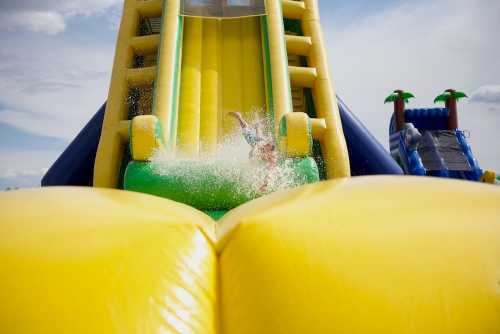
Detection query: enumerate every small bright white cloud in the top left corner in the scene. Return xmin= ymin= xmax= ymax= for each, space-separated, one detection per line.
xmin=0 ymin=11 xmax=66 ymax=35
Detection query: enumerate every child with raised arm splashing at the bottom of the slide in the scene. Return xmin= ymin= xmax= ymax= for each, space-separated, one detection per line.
xmin=228 ymin=111 xmax=278 ymax=193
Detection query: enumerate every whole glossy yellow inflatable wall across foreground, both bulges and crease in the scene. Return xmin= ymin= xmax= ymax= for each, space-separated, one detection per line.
xmin=0 ymin=176 xmax=500 ymax=334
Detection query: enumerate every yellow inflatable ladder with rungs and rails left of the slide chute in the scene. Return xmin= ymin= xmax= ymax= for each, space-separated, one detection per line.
xmin=94 ymin=0 xmax=181 ymax=188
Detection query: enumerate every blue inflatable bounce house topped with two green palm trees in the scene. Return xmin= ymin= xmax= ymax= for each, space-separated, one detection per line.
xmin=385 ymin=89 xmax=496 ymax=183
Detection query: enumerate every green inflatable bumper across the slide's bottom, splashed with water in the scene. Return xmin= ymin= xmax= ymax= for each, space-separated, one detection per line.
xmin=124 ymin=158 xmax=319 ymax=211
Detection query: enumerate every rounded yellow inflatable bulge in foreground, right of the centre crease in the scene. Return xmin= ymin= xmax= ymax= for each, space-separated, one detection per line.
xmin=218 ymin=177 xmax=500 ymax=334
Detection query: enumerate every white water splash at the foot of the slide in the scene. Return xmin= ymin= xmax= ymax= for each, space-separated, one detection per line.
xmin=150 ymin=111 xmax=304 ymax=204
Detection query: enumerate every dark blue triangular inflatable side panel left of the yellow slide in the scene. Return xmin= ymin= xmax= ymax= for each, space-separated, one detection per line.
xmin=42 ymin=104 xmax=106 ymax=187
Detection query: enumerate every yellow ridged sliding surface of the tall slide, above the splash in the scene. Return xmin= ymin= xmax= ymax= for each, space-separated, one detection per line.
xmin=177 ymin=17 xmax=265 ymax=157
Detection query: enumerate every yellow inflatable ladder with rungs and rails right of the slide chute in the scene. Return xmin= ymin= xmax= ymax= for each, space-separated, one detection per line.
xmin=272 ymin=0 xmax=350 ymax=179
